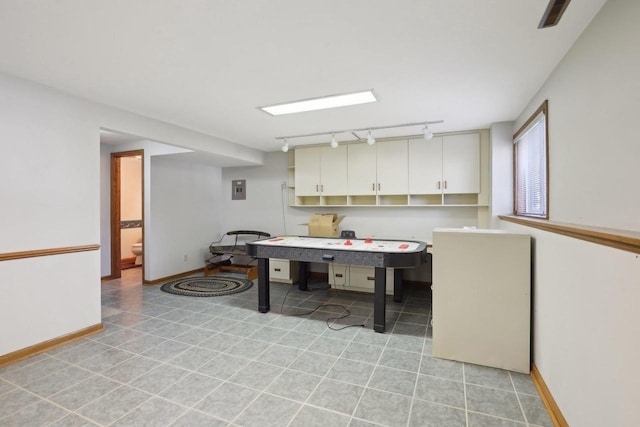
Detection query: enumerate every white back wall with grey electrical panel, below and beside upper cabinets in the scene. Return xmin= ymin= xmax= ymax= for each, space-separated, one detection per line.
xmin=221 ymin=150 xmax=489 ymax=281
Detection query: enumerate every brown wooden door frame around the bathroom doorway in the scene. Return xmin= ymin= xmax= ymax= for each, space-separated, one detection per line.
xmin=110 ymin=150 xmax=147 ymax=282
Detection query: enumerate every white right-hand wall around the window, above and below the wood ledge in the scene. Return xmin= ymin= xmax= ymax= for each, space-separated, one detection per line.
xmin=494 ymin=0 xmax=640 ymax=426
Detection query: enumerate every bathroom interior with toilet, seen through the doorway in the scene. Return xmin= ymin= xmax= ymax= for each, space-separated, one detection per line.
xmin=120 ymin=155 xmax=143 ymax=270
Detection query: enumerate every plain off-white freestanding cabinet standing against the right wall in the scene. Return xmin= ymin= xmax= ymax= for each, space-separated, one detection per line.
xmin=432 ymin=229 xmax=531 ymax=373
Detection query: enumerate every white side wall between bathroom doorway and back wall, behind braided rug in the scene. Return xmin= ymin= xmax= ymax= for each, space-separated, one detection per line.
xmin=145 ymin=155 xmax=222 ymax=280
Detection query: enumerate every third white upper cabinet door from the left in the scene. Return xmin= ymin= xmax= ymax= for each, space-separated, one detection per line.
xmin=348 ymin=144 xmax=376 ymax=196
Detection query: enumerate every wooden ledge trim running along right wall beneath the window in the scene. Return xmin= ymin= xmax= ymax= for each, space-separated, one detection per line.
xmin=498 ymin=215 xmax=640 ymax=254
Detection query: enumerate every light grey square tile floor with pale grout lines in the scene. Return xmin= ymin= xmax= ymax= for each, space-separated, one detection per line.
xmin=0 ymin=269 xmax=552 ymax=427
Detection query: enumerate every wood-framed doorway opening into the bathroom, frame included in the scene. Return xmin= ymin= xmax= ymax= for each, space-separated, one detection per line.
xmin=110 ymin=150 xmax=146 ymax=281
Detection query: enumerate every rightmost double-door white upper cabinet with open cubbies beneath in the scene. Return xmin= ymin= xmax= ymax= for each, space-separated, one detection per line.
xmin=409 ymin=133 xmax=480 ymax=204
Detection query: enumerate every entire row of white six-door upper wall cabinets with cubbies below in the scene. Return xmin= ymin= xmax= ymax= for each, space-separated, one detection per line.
xmin=290 ymin=132 xmax=488 ymax=206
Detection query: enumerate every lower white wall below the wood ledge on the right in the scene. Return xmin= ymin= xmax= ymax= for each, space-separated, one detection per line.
xmin=501 ymin=223 xmax=640 ymax=427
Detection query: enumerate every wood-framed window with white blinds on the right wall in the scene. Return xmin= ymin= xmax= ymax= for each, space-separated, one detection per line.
xmin=513 ymin=101 xmax=549 ymax=218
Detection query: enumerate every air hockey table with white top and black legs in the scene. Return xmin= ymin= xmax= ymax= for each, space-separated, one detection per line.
xmin=246 ymin=236 xmax=427 ymax=332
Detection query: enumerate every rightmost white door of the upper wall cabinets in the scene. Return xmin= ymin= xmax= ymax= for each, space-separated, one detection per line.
xmin=444 ymin=133 xmax=480 ymax=194
